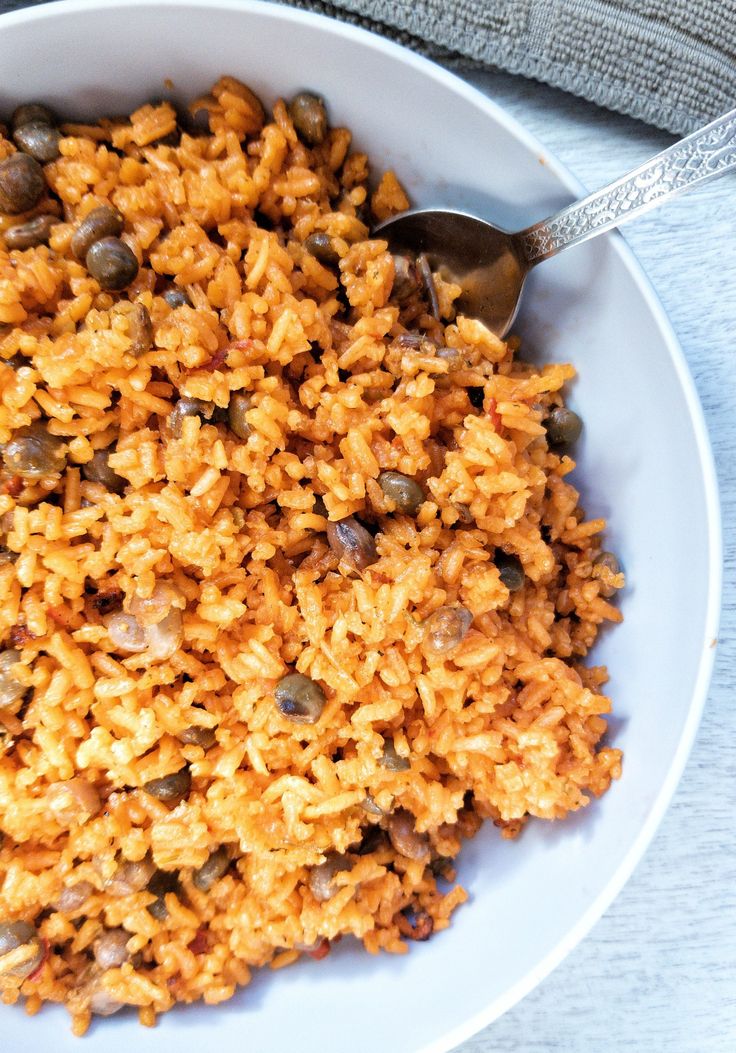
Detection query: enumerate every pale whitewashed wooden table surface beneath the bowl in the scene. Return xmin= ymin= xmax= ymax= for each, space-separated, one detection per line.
xmin=457 ymin=73 xmax=736 ymax=1053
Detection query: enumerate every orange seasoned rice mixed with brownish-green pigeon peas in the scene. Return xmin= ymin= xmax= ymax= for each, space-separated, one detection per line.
xmin=0 ymin=77 xmax=623 ymax=1034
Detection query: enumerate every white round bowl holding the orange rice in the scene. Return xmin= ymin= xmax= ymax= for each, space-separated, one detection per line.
xmin=0 ymin=0 xmax=720 ymax=1053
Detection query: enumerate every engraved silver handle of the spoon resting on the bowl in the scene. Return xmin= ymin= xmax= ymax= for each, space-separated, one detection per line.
xmin=516 ymin=110 xmax=736 ymax=266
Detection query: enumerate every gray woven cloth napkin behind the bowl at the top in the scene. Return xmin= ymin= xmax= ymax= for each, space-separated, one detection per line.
xmin=0 ymin=0 xmax=736 ymax=134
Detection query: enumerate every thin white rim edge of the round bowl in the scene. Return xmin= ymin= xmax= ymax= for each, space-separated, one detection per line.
xmin=0 ymin=0 xmax=723 ymax=1053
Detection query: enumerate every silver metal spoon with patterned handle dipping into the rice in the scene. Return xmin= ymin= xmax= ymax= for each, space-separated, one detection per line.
xmin=376 ymin=102 xmax=736 ymax=336
